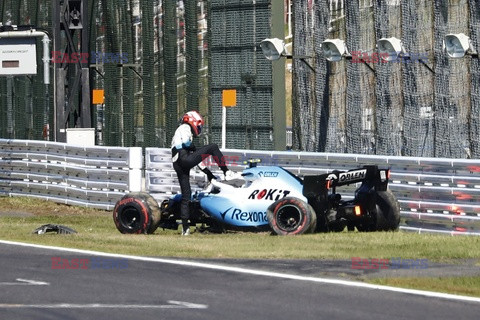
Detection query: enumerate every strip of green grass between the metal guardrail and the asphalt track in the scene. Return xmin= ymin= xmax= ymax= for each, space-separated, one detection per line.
xmin=0 ymin=197 xmax=480 ymax=296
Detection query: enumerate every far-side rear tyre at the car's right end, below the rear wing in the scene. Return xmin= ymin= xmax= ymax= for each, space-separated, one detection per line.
xmin=376 ymin=190 xmax=400 ymax=231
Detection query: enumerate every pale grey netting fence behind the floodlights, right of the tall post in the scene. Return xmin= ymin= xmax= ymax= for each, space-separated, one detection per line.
xmin=292 ymin=0 xmax=480 ymax=158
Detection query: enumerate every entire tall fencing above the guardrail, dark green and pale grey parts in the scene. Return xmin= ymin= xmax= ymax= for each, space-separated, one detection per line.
xmin=0 ymin=0 xmax=480 ymax=158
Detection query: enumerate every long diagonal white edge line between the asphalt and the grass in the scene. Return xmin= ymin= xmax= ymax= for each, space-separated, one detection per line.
xmin=0 ymin=240 xmax=480 ymax=303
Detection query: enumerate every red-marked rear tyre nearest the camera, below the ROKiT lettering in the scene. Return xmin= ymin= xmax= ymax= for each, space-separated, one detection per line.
xmin=267 ymin=197 xmax=317 ymax=235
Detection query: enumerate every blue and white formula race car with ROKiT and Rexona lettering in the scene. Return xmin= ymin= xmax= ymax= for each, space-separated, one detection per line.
xmin=113 ymin=161 xmax=400 ymax=235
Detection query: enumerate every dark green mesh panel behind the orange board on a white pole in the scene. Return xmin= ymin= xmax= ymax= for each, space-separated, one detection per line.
xmin=208 ymin=0 xmax=274 ymax=150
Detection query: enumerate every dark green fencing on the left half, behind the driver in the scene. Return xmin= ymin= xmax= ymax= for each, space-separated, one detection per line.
xmin=0 ymin=0 xmax=273 ymax=149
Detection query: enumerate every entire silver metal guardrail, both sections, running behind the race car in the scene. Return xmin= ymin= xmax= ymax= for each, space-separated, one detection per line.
xmin=0 ymin=139 xmax=480 ymax=235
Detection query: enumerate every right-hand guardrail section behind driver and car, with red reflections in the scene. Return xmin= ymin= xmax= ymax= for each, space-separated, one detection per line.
xmin=145 ymin=148 xmax=480 ymax=235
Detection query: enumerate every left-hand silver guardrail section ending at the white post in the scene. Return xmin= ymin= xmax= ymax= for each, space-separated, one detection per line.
xmin=0 ymin=139 xmax=143 ymax=210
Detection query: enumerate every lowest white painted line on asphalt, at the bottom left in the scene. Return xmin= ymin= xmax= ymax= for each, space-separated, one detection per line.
xmin=0 ymin=300 xmax=208 ymax=309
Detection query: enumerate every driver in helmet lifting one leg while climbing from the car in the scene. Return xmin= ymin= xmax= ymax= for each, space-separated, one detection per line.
xmin=172 ymin=111 xmax=239 ymax=235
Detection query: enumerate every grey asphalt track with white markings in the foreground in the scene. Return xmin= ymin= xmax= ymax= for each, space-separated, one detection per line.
xmin=0 ymin=242 xmax=480 ymax=320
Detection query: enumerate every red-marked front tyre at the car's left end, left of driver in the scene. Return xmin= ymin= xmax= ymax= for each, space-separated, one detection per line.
xmin=113 ymin=192 xmax=161 ymax=234
